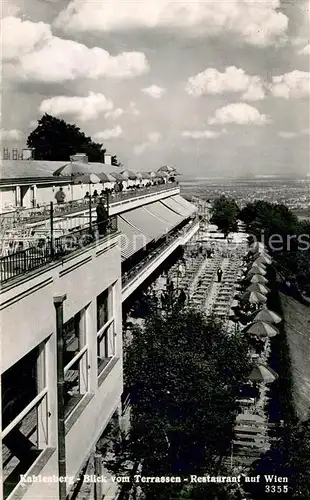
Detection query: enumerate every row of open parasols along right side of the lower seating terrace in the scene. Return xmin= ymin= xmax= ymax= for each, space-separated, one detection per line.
xmin=241 ymin=242 xmax=282 ymax=384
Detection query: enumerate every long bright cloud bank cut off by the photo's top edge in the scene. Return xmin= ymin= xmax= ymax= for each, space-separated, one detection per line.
xmin=55 ymin=0 xmax=288 ymax=46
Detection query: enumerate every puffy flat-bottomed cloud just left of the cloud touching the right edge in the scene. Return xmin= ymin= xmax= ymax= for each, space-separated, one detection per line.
xmin=186 ymin=66 xmax=265 ymax=101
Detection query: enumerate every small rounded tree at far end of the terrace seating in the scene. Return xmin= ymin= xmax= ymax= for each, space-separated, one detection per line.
xmin=210 ymin=196 xmax=239 ymax=238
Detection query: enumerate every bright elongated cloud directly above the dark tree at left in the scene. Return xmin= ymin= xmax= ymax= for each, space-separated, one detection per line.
xmin=39 ymin=92 xmax=113 ymax=121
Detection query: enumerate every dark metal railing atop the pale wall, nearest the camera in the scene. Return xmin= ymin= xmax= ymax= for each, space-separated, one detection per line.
xmin=0 ymin=216 xmax=117 ymax=283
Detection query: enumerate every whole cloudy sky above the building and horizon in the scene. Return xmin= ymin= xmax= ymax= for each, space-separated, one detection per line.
xmin=2 ymin=0 xmax=310 ymax=177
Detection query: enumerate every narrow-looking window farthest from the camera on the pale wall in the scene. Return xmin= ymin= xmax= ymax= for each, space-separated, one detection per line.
xmin=97 ymin=286 xmax=115 ymax=375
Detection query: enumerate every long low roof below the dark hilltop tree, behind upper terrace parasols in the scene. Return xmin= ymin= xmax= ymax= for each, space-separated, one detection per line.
xmin=0 ymin=160 xmax=120 ymax=180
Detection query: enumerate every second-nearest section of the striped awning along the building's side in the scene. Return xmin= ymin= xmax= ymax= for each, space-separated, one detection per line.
xmin=122 ymin=207 xmax=170 ymax=240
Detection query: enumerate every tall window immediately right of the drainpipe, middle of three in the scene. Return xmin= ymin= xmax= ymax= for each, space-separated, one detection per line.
xmin=63 ymin=309 xmax=88 ymax=416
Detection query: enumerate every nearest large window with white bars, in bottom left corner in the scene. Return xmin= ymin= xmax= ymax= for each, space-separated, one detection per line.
xmin=1 ymin=343 xmax=48 ymax=498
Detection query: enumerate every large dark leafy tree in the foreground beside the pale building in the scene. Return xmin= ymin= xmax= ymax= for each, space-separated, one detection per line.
xmin=105 ymin=289 xmax=251 ymax=500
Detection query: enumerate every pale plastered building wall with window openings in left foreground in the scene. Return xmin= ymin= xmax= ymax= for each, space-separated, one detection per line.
xmin=1 ymin=235 xmax=123 ymax=500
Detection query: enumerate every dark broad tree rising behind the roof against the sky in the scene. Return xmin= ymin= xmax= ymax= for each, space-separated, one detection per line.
xmin=27 ymin=113 xmax=117 ymax=163
